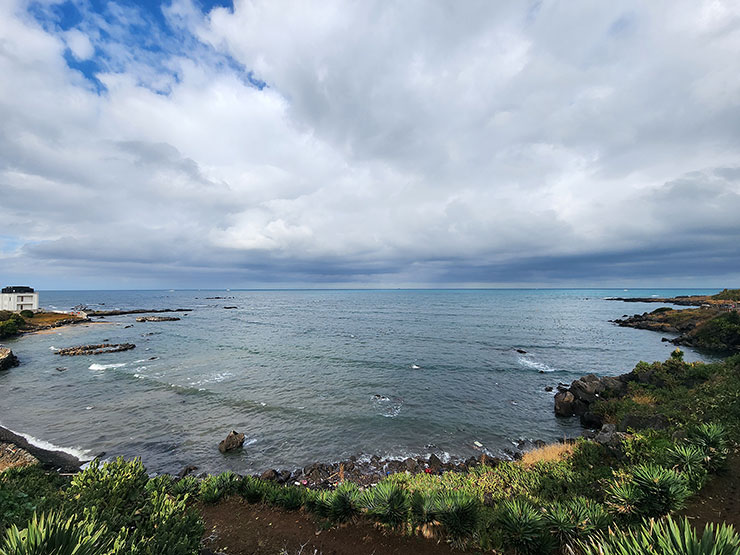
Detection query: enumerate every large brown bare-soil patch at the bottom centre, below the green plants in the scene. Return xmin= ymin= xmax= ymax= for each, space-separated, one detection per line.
xmin=199 ymin=497 xmax=466 ymax=555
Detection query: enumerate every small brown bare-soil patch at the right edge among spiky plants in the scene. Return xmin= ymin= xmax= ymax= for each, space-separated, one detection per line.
xmin=679 ymin=451 xmax=740 ymax=530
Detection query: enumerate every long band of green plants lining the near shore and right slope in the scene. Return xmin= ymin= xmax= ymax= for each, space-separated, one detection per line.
xmin=0 ymin=351 xmax=740 ymax=555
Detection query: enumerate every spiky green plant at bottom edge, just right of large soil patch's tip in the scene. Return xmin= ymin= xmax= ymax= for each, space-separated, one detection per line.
xmin=495 ymin=499 xmax=552 ymax=554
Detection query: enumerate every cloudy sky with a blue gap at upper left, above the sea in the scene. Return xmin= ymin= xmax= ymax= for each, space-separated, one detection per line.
xmin=0 ymin=0 xmax=740 ymax=289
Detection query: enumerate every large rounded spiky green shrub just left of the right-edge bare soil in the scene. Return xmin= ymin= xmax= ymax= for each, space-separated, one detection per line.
xmin=607 ymin=464 xmax=689 ymax=517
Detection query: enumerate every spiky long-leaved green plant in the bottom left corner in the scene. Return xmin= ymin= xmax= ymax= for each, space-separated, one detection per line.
xmin=0 ymin=513 xmax=110 ymax=555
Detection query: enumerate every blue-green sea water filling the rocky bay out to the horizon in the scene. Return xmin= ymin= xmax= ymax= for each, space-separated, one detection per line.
xmin=0 ymin=289 xmax=717 ymax=472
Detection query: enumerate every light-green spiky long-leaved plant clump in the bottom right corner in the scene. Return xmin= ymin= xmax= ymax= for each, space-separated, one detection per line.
xmin=580 ymin=516 xmax=740 ymax=555
